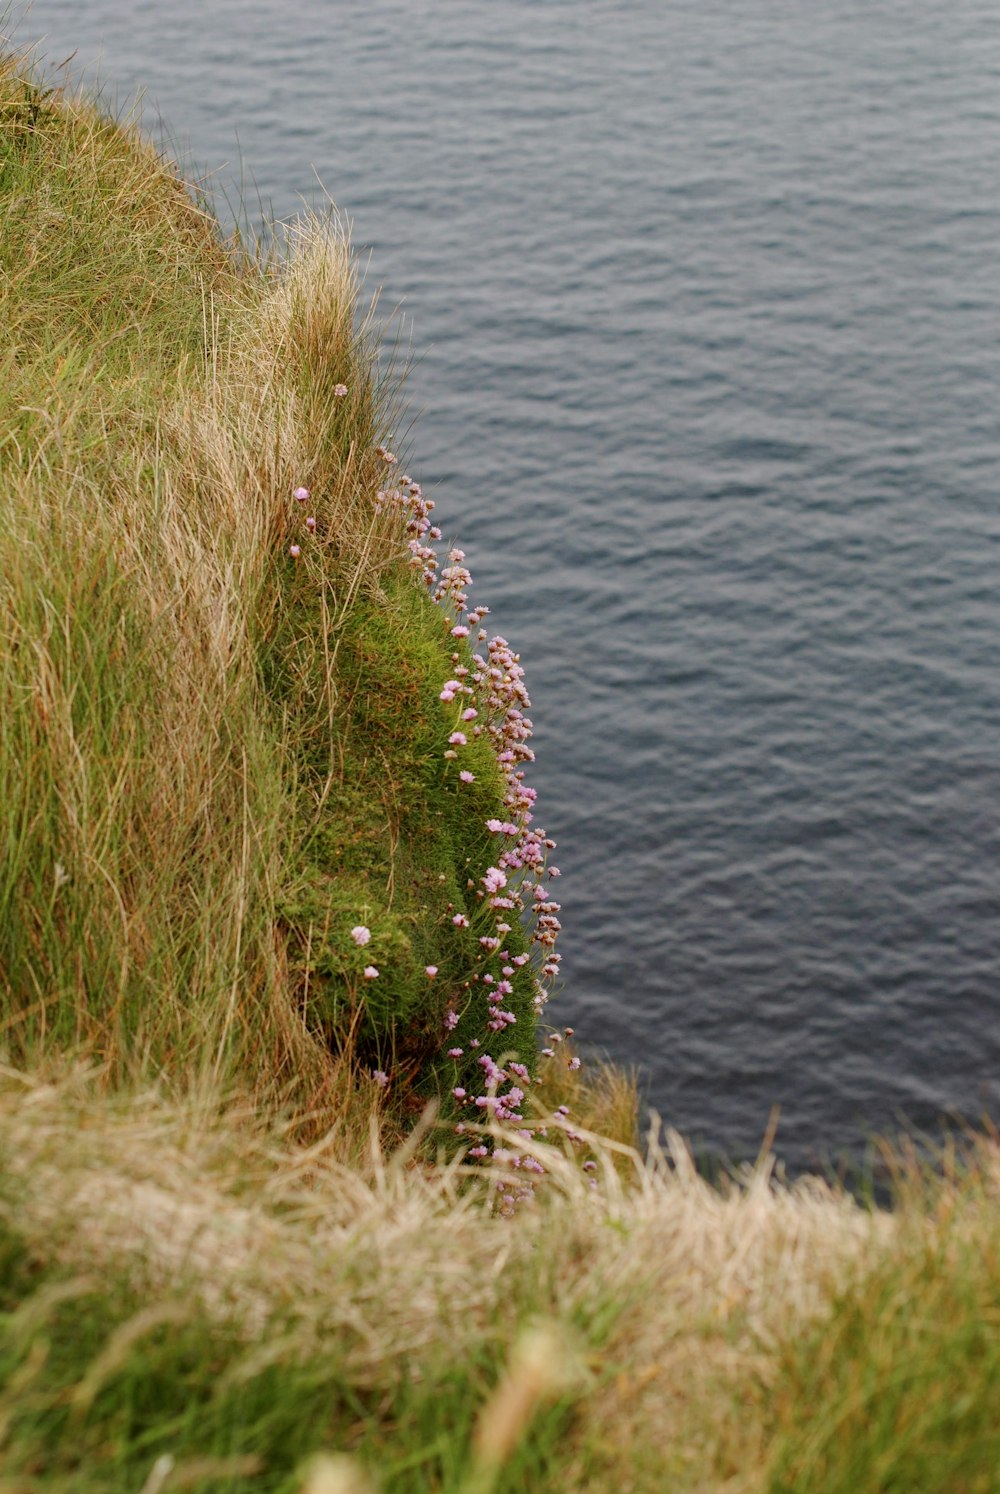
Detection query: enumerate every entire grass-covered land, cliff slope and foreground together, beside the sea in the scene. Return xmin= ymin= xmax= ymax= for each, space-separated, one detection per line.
xmin=0 ymin=49 xmax=1000 ymax=1494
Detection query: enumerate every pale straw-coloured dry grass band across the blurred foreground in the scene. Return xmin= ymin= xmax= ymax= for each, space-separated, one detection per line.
xmin=0 ymin=1073 xmax=898 ymax=1490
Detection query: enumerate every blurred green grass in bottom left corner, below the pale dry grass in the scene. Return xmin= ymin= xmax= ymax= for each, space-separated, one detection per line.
xmin=0 ymin=1225 xmax=585 ymax=1494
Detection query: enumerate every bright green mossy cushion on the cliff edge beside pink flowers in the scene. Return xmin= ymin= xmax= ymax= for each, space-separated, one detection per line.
xmin=268 ymin=568 xmax=534 ymax=1076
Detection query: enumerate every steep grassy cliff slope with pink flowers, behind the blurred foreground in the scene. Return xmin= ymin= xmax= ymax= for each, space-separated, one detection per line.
xmin=0 ymin=61 xmax=558 ymax=1115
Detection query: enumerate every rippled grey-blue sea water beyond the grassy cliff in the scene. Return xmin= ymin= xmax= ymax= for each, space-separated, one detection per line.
xmin=18 ymin=0 xmax=1000 ymax=1165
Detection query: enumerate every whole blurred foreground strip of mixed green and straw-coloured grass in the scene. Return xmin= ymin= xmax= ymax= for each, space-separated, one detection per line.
xmin=0 ymin=1076 xmax=1000 ymax=1494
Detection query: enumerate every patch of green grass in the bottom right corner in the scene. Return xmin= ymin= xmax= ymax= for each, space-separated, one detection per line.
xmin=768 ymin=1219 xmax=1000 ymax=1494
